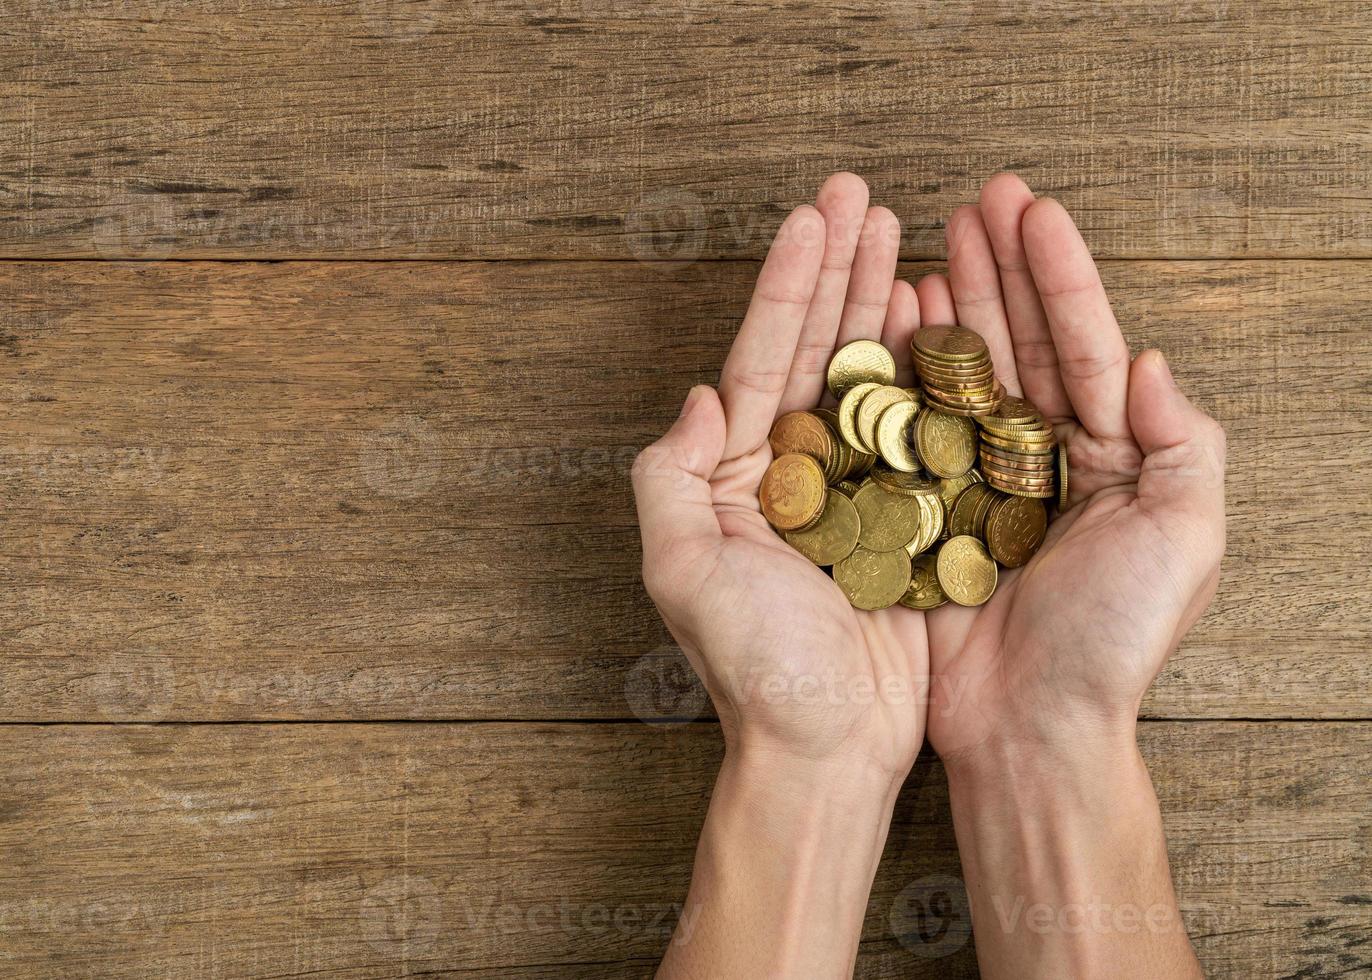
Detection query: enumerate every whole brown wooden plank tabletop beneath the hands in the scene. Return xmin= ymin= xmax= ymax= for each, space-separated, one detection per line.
xmin=0 ymin=0 xmax=1372 ymax=979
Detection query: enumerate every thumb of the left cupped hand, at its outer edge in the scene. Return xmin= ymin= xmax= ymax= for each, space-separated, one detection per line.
xmin=632 ymin=384 xmax=724 ymax=593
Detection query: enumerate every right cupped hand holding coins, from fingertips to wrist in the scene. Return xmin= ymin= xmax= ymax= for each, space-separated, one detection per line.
xmin=918 ymin=174 xmax=1225 ymax=762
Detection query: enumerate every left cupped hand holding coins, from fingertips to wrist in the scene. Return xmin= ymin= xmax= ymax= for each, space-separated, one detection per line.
xmin=634 ymin=173 xmax=927 ymax=780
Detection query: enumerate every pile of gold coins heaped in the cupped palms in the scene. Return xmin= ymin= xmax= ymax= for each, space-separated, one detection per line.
xmin=759 ymin=327 xmax=1067 ymax=609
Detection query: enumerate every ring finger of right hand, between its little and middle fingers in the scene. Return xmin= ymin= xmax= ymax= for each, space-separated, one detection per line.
xmin=944 ymin=205 xmax=1022 ymax=395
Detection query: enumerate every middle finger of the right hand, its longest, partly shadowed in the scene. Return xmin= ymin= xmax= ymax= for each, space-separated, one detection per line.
xmin=981 ymin=173 xmax=1072 ymax=420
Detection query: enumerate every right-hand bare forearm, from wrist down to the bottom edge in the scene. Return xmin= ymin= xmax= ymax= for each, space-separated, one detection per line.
xmin=948 ymin=732 xmax=1201 ymax=980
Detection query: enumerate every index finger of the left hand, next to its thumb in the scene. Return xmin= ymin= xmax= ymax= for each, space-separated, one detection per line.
xmin=719 ymin=205 xmax=825 ymax=460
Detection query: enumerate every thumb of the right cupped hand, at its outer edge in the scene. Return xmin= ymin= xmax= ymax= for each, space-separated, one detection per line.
xmin=1129 ymin=350 xmax=1225 ymax=535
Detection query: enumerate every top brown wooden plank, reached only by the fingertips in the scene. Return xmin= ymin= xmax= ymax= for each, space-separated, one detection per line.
xmin=0 ymin=0 xmax=1372 ymax=261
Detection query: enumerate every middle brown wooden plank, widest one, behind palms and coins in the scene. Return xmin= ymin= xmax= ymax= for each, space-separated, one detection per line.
xmin=0 ymin=255 xmax=1372 ymax=721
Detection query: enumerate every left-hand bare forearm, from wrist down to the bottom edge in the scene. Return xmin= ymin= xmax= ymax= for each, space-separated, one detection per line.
xmin=657 ymin=751 xmax=899 ymax=980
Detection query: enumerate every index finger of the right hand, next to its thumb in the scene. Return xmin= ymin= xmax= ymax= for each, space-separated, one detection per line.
xmin=1022 ymin=198 xmax=1129 ymax=439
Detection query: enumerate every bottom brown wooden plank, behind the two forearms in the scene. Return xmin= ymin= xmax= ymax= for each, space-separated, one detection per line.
xmin=0 ymin=722 xmax=1372 ymax=980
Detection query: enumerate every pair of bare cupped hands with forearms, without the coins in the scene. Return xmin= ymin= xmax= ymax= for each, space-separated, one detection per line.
xmin=634 ymin=174 xmax=1224 ymax=977
